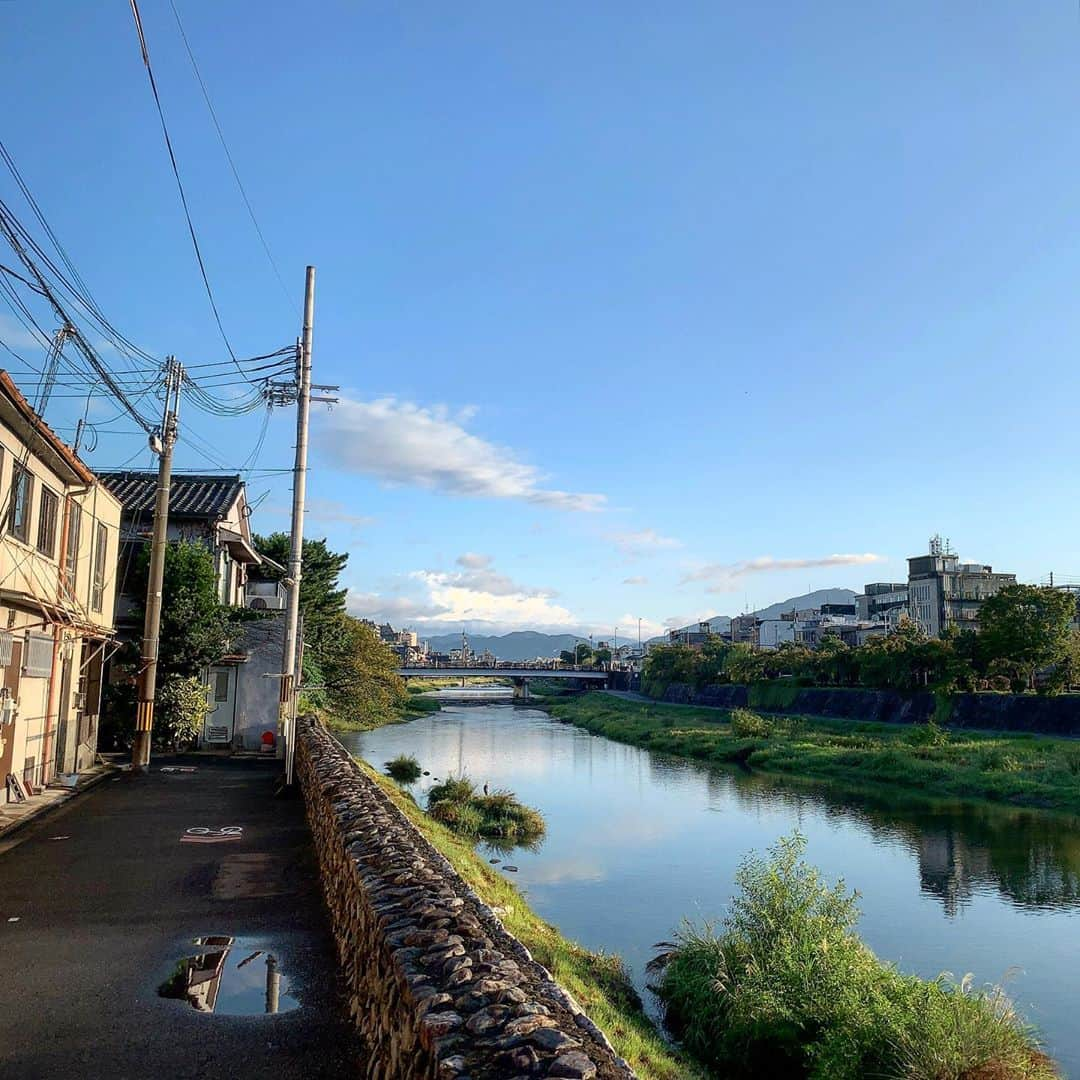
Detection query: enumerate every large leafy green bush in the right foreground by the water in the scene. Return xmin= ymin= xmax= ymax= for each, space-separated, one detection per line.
xmin=651 ymin=834 xmax=1055 ymax=1080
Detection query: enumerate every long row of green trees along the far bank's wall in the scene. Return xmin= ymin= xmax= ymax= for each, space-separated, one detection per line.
xmin=642 ymin=585 xmax=1080 ymax=697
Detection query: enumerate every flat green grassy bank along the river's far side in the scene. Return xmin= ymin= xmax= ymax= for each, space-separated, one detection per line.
xmin=544 ymin=693 xmax=1080 ymax=814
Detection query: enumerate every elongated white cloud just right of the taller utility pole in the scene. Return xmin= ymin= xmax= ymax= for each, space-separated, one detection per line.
xmin=315 ymin=397 xmax=605 ymax=511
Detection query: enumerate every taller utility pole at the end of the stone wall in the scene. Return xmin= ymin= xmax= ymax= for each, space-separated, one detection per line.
xmin=279 ymin=267 xmax=315 ymax=785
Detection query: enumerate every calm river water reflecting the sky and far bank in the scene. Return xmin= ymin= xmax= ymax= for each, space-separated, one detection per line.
xmin=341 ymin=690 xmax=1080 ymax=1078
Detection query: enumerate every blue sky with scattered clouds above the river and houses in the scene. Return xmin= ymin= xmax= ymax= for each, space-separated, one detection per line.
xmin=0 ymin=0 xmax=1080 ymax=634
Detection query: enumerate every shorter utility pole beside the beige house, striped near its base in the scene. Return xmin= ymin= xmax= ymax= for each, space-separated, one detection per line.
xmin=132 ymin=356 xmax=184 ymax=772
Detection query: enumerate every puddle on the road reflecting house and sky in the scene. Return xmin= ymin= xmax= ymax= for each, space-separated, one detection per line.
xmin=158 ymin=935 xmax=300 ymax=1016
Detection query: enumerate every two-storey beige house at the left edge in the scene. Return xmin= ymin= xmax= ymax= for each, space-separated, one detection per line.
xmin=0 ymin=372 xmax=120 ymax=799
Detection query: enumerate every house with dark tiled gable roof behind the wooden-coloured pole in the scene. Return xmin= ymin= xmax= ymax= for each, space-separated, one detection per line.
xmin=99 ymin=471 xmax=259 ymax=638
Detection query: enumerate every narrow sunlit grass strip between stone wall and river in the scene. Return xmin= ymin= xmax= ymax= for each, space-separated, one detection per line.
xmin=360 ymin=761 xmax=703 ymax=1080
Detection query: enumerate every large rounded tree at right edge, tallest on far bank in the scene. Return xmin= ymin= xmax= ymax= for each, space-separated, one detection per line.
xmin=978 ymin=585 xmax=1077 ymax=692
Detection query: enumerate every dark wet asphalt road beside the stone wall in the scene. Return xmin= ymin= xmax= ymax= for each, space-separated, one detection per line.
xmin=0 ymin=758 xmax=363 ymax=1080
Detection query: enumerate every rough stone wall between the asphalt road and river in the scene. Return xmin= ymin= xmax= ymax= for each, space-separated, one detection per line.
xmin=297 ymin=719 xmax=634 ymax=1080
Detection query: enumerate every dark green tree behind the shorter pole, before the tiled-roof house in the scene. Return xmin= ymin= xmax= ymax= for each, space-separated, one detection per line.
xmin=125 ymin=540 xmax=251 ymax=680
